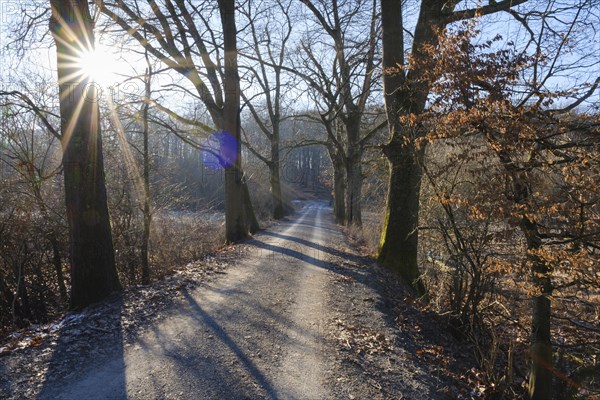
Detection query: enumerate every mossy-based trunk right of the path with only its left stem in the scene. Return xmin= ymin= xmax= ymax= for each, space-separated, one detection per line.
xmin=377 ymin=0 xmax=425 ymax=294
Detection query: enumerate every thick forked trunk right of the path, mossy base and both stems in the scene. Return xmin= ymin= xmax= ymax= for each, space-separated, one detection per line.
xmin=378 ymin=0 xmax=457 ymax=294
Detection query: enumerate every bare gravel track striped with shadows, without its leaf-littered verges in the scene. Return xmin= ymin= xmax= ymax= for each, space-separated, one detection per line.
xmin=41 ymin=202 xmax=330 ymax=399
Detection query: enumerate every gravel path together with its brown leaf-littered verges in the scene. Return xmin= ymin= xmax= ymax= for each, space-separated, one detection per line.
xmin=0 ymin=201 xmax=486 ymax=400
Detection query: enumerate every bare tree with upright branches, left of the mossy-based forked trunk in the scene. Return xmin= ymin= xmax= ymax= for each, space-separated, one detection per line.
xmin=301 ymin=0 xmax=385 ymax=226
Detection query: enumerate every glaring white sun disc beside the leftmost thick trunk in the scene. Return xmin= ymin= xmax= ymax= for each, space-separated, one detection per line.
xmin=77 ymin=45 xmax=120 ymax=87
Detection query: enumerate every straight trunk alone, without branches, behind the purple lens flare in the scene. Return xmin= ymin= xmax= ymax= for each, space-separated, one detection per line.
xmin=219 ymin=0 xmax=259 ymax=243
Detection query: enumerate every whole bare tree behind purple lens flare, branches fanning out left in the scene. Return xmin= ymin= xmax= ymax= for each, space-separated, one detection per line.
xmin=97 ymin=0 xmax=259 ymax=242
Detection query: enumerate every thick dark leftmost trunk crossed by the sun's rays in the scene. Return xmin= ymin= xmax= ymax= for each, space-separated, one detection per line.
xmin=50 ymin=0 xmax=121 ymax=308
